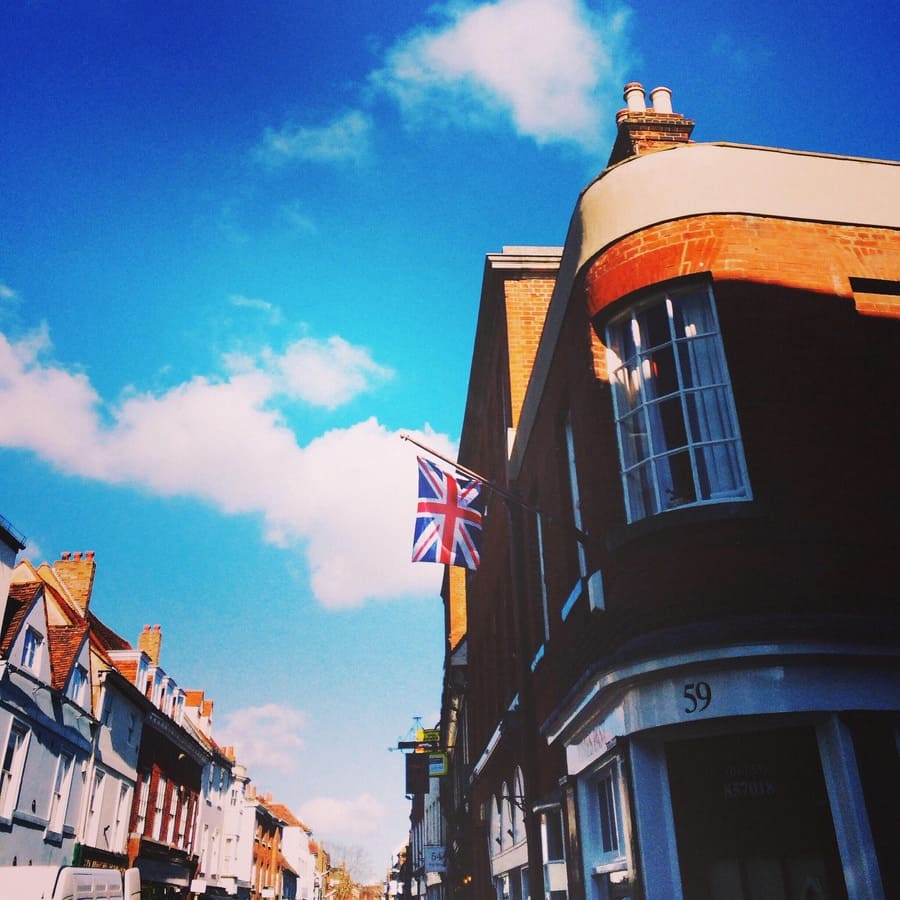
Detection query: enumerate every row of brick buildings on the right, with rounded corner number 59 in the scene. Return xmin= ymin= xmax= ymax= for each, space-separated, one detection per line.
xmin=442 ymin=84 xmax=900 ymax=900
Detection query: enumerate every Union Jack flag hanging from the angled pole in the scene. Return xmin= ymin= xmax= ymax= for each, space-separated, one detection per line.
xmin=412 ymin=456 xmax=483 ymax=569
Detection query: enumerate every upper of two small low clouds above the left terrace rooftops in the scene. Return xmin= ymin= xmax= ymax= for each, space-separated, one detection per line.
xmin=216 ymin=703 xmax=306 ymax=772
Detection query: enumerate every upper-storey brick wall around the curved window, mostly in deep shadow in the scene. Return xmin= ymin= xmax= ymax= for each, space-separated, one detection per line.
xmin=521 ymin=216 xmax=900 ymax=718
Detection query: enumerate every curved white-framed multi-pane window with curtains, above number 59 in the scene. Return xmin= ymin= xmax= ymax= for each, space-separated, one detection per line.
xmin=606 ymin=283 xmax=751 ymax=522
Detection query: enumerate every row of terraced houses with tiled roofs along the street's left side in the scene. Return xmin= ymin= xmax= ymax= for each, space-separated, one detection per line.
xmin=0 ymin=540 xmax=322 ymax=900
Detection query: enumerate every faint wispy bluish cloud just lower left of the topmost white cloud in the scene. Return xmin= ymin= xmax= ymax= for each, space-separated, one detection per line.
xmin=256 ymin=109 xmax=372 ymax=166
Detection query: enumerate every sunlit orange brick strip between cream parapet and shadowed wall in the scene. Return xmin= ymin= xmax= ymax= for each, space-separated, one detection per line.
xmin=586 ymin=215 xmax=900 ymax=317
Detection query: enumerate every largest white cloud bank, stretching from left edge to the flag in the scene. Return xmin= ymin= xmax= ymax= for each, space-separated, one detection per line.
xmin=0 ymin=322 xmax=453 ymax=608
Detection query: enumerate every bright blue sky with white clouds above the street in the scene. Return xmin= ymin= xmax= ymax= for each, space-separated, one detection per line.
xmin=0 ymin=0 xmax=900 ymax=876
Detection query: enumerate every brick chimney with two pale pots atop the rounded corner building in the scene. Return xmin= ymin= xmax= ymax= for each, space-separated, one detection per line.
xmin=607 ymin=81 xmax=694 ymax=166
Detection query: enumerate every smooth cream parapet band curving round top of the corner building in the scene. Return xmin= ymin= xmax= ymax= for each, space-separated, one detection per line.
xmin=512 ymin=142 xmax=900 ymax=480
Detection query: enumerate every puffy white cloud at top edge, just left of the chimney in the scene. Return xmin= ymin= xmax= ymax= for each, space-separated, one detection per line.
xmin=372 ymin=0 xmax=629 ymax=147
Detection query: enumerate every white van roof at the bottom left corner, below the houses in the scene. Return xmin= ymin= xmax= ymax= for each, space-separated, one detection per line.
xmin=0 ymin=866 xmax=141 ymax=900
